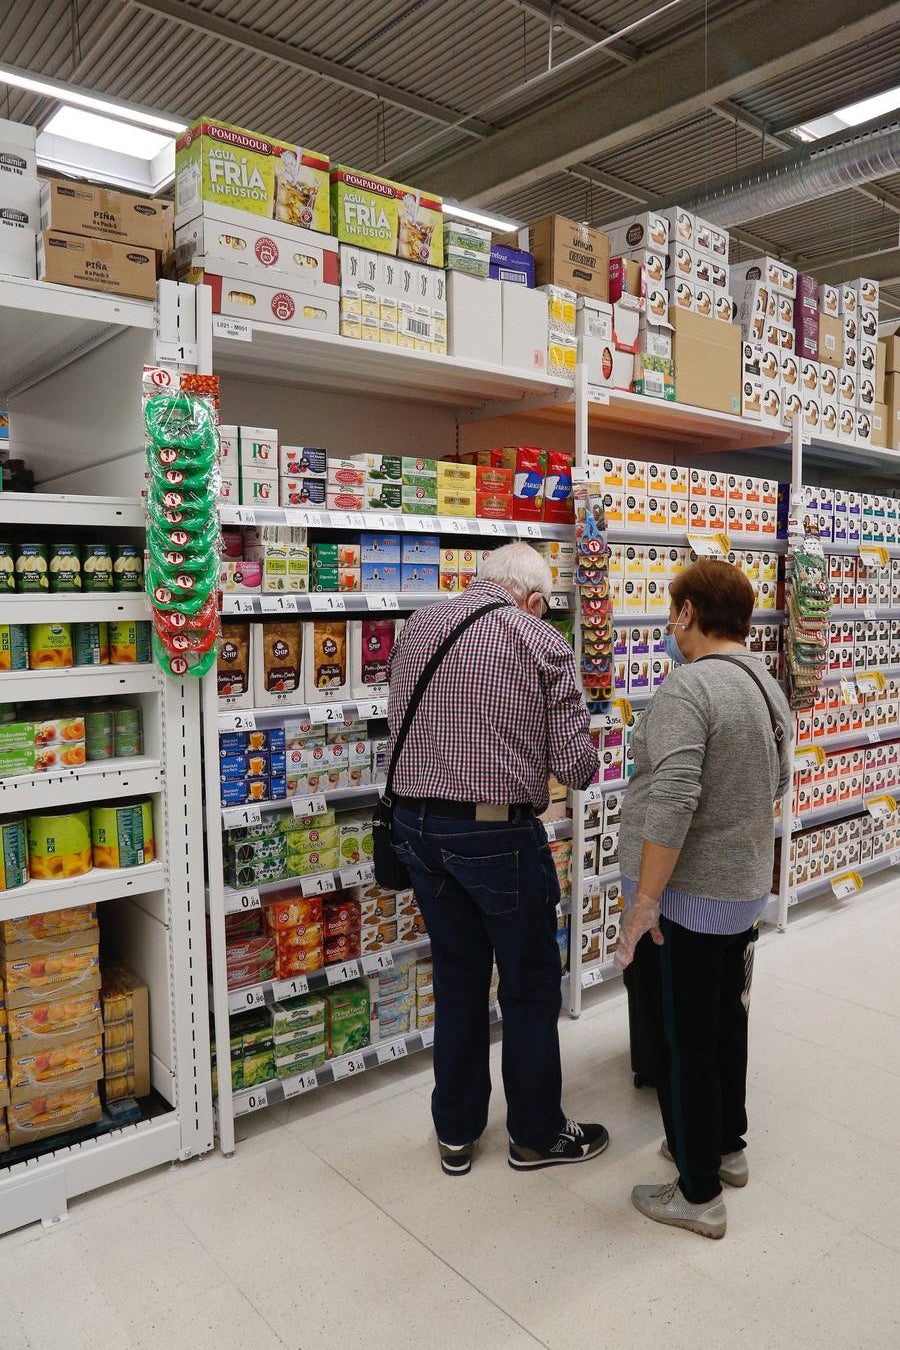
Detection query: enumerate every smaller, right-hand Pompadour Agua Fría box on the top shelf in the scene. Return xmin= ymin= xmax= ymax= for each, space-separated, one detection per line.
xmin=331 ymin=165 xmax=444 ymax=267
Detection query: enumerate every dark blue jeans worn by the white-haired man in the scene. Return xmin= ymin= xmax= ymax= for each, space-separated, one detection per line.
xmin=394 ymin=807 xmax=565 ymax=1149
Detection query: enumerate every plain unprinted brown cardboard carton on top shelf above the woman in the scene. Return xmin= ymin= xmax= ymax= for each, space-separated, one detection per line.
xmin=671 ymin=308 xmax=741 ymax=416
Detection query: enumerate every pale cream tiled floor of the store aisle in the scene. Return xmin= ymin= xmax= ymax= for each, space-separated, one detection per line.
xmin=0 ymin=882 xmax=900 ymax=1350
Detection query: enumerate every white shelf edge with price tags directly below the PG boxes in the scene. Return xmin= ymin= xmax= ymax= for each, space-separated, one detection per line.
xmin=219 ymin=506 xmax=573 ymax=540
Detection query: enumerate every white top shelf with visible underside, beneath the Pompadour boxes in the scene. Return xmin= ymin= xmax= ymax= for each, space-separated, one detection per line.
xmin=213 ymin=321 xmax=572 ymax=416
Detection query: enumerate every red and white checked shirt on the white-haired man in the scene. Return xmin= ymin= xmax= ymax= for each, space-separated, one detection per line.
xmin=387 ymin=582 xmax=598 ymax=813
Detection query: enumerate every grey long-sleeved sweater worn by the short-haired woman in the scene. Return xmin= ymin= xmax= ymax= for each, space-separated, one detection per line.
xmin=619 ymin=652 xmax=792 ymax=900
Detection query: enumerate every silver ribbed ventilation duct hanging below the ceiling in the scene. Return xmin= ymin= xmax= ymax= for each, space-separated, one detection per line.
xmin=684 ymin=122 xmax=900 ymax=228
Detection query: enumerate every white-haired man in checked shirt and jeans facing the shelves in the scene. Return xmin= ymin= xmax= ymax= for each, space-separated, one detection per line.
xmin=389 ymin=544 xmax=609 ymax=1176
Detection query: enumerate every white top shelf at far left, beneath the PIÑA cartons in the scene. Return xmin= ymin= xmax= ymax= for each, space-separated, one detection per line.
xmin=0 ymin=277 xmax=155 ymax=398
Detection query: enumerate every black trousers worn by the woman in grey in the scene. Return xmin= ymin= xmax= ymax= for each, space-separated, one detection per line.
xmin=633 ymin=918 xmax=754 ymax=1204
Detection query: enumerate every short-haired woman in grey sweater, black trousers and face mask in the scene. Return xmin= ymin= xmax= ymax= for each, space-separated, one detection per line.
xmin=617 ymin=559 xmax=792 ymax=1238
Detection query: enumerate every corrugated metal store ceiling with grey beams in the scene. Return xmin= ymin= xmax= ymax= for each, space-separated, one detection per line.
xmin=0 ymin=0 xmax=900 ymax=315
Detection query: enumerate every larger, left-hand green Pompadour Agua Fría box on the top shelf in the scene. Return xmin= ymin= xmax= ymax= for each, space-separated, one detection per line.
xmin=175 ymin=117 xmax=331 ymax=234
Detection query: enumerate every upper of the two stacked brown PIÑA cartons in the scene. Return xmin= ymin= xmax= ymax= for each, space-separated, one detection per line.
xmin=40 ymin=181 xmax=174 ymax=252
